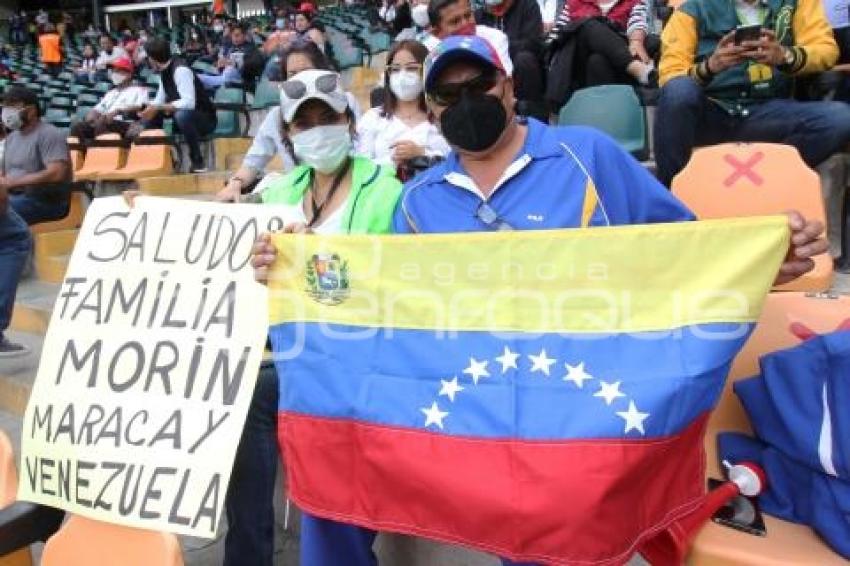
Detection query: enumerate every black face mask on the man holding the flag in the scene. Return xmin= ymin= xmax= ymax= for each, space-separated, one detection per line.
xmin=440 ymin=92 xmax=508 ymax=152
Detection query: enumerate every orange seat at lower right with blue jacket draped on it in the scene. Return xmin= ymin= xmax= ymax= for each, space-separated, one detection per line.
xmin=687 ymin=292 xmax=850 ymax=566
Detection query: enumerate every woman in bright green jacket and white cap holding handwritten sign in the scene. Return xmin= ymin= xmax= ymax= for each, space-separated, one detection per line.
xmin=237 ymin=69 xmax=401 ymax=565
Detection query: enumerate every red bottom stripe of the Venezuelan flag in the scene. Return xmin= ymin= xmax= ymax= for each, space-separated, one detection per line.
xmin=278 ymin=412 xmax=707 ymax=566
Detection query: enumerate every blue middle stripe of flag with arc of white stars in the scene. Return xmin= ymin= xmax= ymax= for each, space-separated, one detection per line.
xmin=270 ymin=323 xmax=752 ymax=440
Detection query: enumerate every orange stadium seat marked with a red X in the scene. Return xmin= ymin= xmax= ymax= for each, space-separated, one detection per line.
xmin=672 ymin=143 xmax=833 ymax=291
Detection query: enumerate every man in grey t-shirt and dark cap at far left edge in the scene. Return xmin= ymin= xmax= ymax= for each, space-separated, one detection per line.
xmin=0 ymin=86 xmax=72 ymax=224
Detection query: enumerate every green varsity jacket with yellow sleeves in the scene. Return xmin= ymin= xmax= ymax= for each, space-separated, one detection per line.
xmin=659 ymin=0 xmax=838 ymax=113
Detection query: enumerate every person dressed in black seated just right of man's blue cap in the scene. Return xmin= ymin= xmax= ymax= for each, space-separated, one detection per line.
xmin=475 ymin=0 xmax=549 ymax=122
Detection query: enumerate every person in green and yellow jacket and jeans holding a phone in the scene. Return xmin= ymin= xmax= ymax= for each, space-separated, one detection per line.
xmin=655 ymin=0 xmax=850 ymax=185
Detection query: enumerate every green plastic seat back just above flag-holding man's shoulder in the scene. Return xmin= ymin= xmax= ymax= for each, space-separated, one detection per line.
xmin=558 ymin=85 xmax=647 ymax=159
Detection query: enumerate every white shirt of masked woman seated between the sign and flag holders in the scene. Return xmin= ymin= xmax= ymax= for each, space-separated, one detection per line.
xmin=356 ymin=108 xmax=451 ymax=165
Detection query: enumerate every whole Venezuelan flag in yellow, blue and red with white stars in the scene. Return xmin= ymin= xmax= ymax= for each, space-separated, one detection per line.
xmin=270 ymin=217 xmax=788 ymax=565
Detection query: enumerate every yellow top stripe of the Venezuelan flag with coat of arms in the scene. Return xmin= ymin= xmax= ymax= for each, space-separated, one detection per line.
xmin=269 ymin=216 xmax=789 ymax=333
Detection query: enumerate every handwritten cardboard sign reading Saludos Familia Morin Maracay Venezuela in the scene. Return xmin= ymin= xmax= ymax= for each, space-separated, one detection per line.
xmin=18 ymin=197 xmax=294 ymax=538
